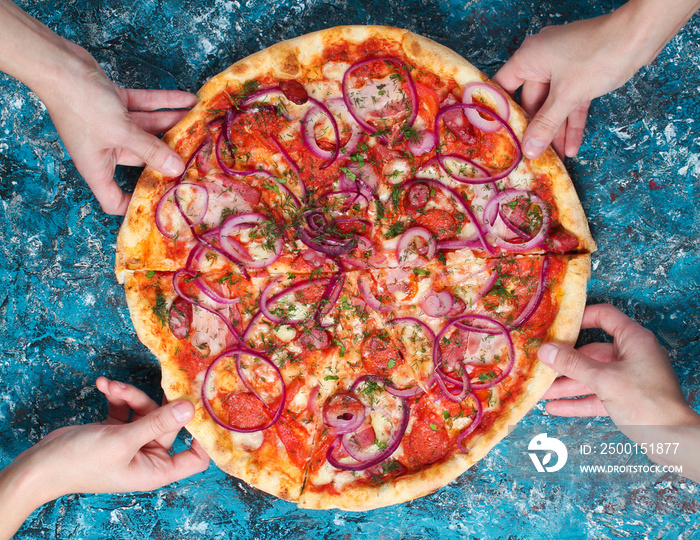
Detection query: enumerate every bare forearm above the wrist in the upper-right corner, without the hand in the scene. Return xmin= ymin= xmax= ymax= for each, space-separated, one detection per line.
xmin=613 ymin=0 xmax=700 ymax=69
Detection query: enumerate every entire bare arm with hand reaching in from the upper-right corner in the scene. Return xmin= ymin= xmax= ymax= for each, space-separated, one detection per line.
xmin=494 ymin=0 xmax=700 ymax=159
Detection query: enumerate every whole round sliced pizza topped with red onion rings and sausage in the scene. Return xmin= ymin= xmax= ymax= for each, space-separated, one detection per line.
xmin=116 ymin=26 xmax=595 ymax=510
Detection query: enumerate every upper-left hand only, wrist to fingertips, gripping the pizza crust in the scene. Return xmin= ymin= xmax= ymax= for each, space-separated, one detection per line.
xmin=37 ymin=42 xmax=197 ymax=215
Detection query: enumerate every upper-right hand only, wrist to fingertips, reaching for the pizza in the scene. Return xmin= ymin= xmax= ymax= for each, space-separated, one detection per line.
xmin=493 ymin=15 xmax=646 ymax=159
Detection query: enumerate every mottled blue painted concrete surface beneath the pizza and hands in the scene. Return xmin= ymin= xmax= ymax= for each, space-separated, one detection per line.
xmin=0 ymin=0 xmax=700 ymax=540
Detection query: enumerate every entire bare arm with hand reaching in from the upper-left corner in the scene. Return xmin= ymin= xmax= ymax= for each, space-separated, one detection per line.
xmin=0 ymin=0 xmax=197 ymax=215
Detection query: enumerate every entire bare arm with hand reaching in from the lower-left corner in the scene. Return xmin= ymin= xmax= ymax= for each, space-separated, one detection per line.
xmin=0 ymin=377 xmax=209 ymax=540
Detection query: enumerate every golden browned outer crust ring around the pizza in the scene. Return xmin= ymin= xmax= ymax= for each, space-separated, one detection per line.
xmin=116 ymin=26 xmax=596 ymax=511
